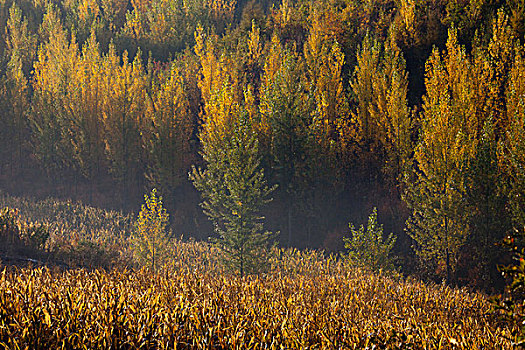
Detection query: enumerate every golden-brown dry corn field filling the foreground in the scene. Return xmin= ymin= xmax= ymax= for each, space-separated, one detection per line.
xmin=0 ymin=247 xmax=512 ymax=349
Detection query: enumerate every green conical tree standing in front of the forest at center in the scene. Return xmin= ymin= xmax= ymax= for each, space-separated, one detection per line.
xmin=190 ymin=113 xmax=274 ymax=277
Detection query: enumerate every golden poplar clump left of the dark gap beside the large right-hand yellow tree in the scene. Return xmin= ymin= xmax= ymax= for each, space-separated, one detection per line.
xmin=351 ymin=32 xmax=414 ymax=189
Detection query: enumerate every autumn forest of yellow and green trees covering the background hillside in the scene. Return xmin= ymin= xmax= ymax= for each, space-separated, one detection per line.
xmin=0 ymin=0 xmax=525 ymax=291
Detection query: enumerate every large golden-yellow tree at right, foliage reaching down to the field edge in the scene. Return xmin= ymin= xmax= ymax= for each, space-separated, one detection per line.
xmin=405 ymin=30 xmax=477 ymax=282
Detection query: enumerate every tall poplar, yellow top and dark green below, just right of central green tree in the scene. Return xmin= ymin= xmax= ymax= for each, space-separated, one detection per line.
xmin=260 ymin=41 xmax=312 ymax=245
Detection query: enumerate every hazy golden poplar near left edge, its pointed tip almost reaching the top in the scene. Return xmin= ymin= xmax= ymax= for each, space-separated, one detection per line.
xmin=30 ymin=4 xmax=79 ymax=179
